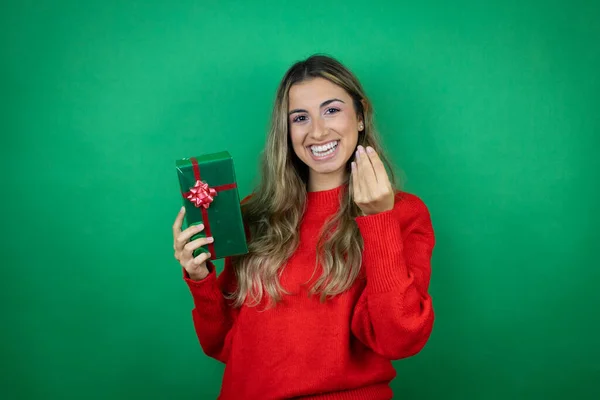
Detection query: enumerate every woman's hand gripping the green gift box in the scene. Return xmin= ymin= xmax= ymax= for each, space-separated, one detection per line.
xmin=173 ymin=207 xmax=213 ymax=281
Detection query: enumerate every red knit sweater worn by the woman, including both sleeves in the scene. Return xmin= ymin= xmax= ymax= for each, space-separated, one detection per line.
xmin=184 ymin=187 xmax=435 ymax=400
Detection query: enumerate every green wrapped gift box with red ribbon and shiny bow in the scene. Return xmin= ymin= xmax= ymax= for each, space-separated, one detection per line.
xmin=175 ymin=151 xmax=248 ymax=260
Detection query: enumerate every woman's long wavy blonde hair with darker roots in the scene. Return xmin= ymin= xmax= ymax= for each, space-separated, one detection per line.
xmin=228 ymin=55 xmax=396 ymax=307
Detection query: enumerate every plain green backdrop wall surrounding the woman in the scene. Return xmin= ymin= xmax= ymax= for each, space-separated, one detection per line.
xmin=0 ymin=0 xmax=600 ymax=399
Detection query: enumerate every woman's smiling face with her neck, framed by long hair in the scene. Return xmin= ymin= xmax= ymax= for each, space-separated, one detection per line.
xmin=288 ymin=78 xmax=363 ymax=191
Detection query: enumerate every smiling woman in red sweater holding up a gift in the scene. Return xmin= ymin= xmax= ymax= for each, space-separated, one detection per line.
xmin=173 ymin=56 xmax=435 ymax=400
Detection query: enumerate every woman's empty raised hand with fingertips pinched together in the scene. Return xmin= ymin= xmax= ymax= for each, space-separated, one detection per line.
xmin=352 ymin=146 xmax=394 ymax=215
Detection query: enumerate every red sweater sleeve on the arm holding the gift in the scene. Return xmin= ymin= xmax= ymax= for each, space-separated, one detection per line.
xmin=183 ymin=258 xmax=239 ymax=363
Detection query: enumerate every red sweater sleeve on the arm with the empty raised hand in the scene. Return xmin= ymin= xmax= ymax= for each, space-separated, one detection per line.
xmin=352 ymin=194 xmax=435 ymax=360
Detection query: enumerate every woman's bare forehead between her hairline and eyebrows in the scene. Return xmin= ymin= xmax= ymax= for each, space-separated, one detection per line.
xmin=289 ymin=78 xmax=351 ymax=109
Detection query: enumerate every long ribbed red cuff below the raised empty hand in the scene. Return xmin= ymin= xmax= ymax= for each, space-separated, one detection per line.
xmin=356 ymin=210 xmax=408 ymax=293
